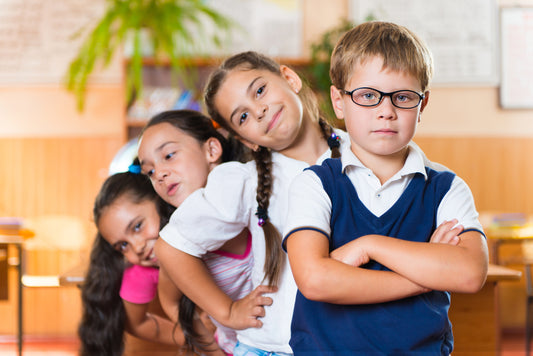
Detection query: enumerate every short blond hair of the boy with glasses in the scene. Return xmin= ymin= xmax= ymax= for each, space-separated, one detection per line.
xmin=329 ymin=21 xmax=433 ymax=92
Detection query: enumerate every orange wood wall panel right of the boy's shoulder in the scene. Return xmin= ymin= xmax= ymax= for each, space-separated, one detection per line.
xmin=415 ymin=137 xmax=533 ymax=214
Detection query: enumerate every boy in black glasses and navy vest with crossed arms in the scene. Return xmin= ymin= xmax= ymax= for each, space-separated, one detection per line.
xmin=284 ymin=22 xmax=488 ymax=356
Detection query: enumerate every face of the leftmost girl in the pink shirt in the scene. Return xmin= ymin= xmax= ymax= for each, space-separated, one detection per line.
xmin=98 ymin=194 xmax=160 ymax=267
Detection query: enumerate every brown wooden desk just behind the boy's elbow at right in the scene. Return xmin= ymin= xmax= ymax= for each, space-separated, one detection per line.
xmin=448 ymin=264 xmax=522 ymax=356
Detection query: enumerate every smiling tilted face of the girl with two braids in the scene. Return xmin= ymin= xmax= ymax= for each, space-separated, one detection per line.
xmin=215 ymin=66 xmax=303 ymax=151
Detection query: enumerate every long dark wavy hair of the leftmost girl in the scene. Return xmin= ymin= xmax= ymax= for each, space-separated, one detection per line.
xmin=78 ymin=172 xmax=174 ymax=356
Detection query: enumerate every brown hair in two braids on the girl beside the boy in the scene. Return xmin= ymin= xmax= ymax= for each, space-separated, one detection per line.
xmin=204 ymin=51 xmax=340 ymax=285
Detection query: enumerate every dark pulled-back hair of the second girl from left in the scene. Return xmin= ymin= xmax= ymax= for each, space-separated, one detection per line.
xmin=140 ymin=110 xmax=250 ymax=351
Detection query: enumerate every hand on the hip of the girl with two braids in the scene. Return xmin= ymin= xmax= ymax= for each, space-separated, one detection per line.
xmin=226 ymin=285 xmax=277 ymax=330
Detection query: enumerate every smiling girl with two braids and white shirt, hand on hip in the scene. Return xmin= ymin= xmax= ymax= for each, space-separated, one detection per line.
xmin=150 ymin=52 xmax=348 ymax=355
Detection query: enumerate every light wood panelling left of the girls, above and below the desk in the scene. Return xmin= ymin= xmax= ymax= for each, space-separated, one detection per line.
xmin=0 ymin=136 xmax=123 ymax=336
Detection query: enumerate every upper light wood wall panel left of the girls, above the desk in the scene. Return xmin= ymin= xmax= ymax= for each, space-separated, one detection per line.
xmin=0 ymin=137 xmax=122 ymax=219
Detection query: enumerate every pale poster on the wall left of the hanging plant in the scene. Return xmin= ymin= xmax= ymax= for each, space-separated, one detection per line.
xmin=0 ymin=0 xmax=121 ymax=85
